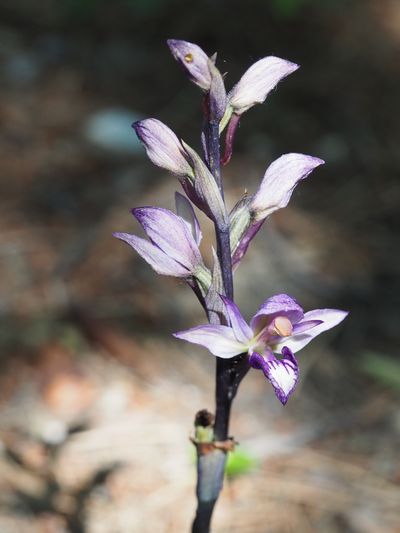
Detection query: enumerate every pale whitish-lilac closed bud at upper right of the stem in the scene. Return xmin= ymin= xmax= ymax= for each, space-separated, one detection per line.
xmin=228 ymin=56 xmax=299 ymax=115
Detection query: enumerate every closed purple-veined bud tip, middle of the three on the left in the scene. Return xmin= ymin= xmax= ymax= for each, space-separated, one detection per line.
xmin=132 ymin=118 xmax=193 ymax=176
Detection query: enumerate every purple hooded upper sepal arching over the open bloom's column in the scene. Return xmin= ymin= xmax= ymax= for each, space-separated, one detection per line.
xmin=250 ymin=294 xmax=304 ymax=334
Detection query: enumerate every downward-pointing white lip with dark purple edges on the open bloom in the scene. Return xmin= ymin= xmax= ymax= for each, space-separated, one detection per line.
xmin=249 ymin=346 xmax=299 ymax=405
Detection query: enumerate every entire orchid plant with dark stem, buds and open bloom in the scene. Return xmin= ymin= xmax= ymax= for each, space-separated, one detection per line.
xmin=114 ymin=39 xmax=347 ymax=533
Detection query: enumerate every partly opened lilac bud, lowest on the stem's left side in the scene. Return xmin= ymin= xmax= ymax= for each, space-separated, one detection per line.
xmin=113 ymin=207 xmax=211 ymax=290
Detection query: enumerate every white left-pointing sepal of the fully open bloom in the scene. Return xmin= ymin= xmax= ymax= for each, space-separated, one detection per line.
xmin=173 ymin=324 xmax=247 ymax=359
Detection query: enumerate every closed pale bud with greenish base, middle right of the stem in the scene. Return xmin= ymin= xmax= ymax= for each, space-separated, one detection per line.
xmin=230 ymin=154 xmax=324 ymax=268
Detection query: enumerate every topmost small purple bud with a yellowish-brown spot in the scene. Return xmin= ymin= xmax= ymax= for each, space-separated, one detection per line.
xmin=167 ymin=39 xmax=211 ymax=91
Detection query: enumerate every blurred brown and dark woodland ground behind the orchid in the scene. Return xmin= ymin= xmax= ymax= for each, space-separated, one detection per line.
xmin=0 ymin=0 xmax=400 ymax=533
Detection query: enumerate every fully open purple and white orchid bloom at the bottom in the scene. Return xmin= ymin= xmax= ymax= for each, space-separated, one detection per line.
xmin=174 ymin=294 xmax=347 ymax=404
